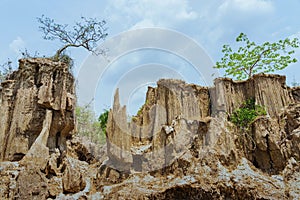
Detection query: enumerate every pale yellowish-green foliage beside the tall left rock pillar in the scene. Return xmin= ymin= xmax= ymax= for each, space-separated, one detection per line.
xmin=75 ymin=106 xmax=106 ymax=145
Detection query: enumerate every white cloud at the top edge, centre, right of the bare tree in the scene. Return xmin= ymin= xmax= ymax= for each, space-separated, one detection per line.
xmin=106 ymin=0 xmax=198 ymax=29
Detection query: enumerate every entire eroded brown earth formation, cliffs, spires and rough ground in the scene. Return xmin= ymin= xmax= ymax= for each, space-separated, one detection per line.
xmin=0 ymin=58 xmax=300 ymax=199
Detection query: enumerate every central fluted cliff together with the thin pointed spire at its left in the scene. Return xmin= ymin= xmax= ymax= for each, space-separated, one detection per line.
xmin=107 ymin=80 xmax=210 ymax=172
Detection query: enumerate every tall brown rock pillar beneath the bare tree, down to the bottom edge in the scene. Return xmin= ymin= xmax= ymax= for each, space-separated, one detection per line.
xmin=0 ymin=58 xmax=77 ymax=199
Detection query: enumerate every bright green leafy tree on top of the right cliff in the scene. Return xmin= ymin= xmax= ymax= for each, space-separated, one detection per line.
xmin=215 ymin=33 xmax=299 ymax=80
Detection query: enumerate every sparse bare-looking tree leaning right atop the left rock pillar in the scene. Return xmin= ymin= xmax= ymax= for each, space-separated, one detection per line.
xmin=37 ymin=15 xmax=107 ymax=60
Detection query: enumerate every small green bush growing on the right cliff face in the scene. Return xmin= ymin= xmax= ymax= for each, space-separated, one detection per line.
xmin=230 ymin=98 xmax=267 ymax=129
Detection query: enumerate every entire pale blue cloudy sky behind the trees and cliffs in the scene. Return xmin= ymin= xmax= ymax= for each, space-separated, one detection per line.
xmin=0 ymin=0 xmax=300 ymax=115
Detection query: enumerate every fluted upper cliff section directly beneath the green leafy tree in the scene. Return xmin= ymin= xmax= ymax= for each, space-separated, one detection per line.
xmin=210 ymin=74 xmax=295 ymax=117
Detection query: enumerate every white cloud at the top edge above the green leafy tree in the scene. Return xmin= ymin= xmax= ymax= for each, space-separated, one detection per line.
xmin=199 ymin=0 xmax=276 ymax=50
